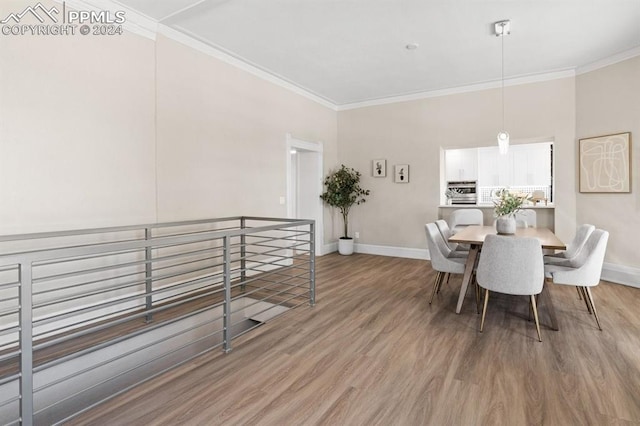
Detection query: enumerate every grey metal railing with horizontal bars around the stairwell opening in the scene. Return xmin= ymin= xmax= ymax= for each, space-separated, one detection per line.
xmin=0 ymin=216 xmax=315 ymax=425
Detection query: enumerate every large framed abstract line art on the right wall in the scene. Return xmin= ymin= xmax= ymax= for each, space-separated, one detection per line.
xmin=578 ymin=132 xmax=631 ymax=193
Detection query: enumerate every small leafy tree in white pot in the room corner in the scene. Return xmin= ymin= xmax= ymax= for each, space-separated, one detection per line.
xmin=320 ymin=164 xmax=369 ymax=255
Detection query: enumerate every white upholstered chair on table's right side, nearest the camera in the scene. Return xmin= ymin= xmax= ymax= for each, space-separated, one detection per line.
xmin=544 ymin=229 xmax=609 ymax=330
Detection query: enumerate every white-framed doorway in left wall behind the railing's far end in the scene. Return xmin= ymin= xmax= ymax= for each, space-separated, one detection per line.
xmin=286 ymin=134 xmax=324 ymax=256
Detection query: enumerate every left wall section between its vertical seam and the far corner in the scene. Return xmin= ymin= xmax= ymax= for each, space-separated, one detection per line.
xmin=157 ymin=36 xmax=337 ymax=225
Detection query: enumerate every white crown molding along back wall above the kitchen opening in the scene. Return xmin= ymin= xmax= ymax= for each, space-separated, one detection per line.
xmin=338 ymin=68 xmax=576 ymax=111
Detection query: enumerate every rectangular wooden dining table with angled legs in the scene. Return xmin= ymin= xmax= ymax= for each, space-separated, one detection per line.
xmin=449 ymin=225 xmax=567 ymax=330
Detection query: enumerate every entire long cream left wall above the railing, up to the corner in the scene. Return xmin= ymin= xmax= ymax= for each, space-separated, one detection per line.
xmin=0 ymin=1 xmax=337 ymax=243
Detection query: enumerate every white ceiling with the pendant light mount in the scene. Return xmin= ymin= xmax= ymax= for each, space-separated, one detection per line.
xmin=111 ymin=0 xmax=640 ymax=106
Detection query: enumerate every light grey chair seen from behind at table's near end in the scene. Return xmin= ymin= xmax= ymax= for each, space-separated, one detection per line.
xmin=476 ymin=235 xmax=544 ymax=342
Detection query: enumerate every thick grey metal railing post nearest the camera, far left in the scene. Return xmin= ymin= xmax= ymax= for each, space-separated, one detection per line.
xmin=19 ymin=261 xmax=33 ymax=426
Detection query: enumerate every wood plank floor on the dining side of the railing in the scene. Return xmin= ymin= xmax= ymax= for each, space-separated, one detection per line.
xmin=70 ymin=254 xmax=640 ymax=425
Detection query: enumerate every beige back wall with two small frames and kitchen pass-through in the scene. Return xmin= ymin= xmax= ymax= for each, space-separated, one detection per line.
xmin=334 ymin=78 xmax=575 ymax=249
